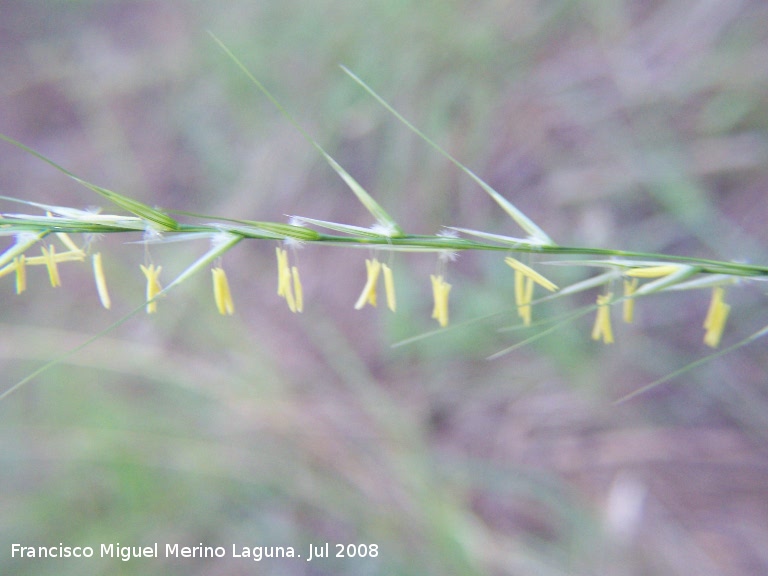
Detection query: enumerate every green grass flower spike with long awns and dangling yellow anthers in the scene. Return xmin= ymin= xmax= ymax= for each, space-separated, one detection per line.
xmin=0 ymin=38 xmax=768 ymax=396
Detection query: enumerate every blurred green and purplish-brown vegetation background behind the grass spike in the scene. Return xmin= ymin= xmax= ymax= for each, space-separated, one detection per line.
xmin=0 ymin=0 xmax=768 ymax=576
